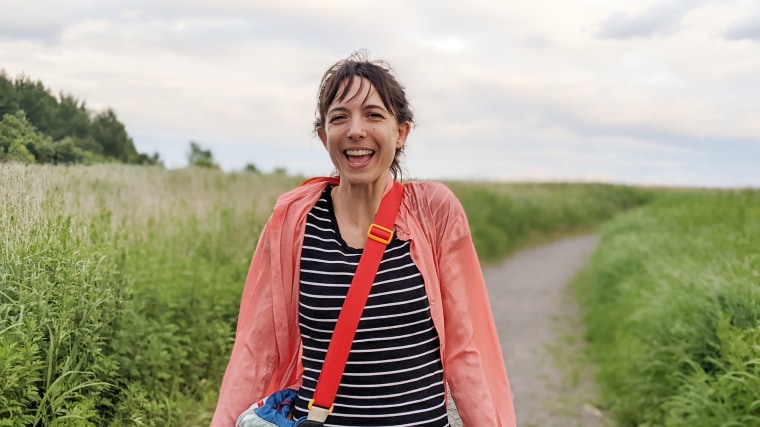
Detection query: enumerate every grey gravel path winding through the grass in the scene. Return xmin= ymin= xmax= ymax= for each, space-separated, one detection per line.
xmin=450 ymin=235 xmax=604 ymax=427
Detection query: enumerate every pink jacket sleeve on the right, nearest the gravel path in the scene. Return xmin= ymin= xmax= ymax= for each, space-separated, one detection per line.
xmin=432 ymin=187 xmax=516 ymax=427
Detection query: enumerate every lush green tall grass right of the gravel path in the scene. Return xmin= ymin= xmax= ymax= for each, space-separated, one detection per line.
xmin=578 ymin=190 xmax=760 ymax=427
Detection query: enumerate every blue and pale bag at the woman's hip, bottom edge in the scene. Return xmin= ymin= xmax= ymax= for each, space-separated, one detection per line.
xmin=235 ymin=388 xmax=306 ymax=427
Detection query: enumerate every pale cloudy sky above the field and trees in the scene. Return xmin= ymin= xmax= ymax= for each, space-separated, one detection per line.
xmin=0 ymin=0 xmax=760 ymax=187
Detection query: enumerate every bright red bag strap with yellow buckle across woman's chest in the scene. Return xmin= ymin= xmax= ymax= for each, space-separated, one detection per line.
xmin=308 ymin=182 xmax=404 ymax=423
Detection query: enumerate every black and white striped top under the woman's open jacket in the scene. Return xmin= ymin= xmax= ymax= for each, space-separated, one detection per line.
xmin=294 ymin=186 xmax=449 ymax=427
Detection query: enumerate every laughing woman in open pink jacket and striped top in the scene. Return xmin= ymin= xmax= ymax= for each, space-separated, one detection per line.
xmin=212 ymin=54 xmax=515 ymax=427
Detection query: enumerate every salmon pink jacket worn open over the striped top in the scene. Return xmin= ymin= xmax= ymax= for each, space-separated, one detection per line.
xmin=211 ymin=179 xmax=516 ymax=427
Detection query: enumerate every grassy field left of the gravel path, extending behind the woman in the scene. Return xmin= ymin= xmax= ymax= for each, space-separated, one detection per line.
xmin=0 ymin=164 xmax=651 ymax=427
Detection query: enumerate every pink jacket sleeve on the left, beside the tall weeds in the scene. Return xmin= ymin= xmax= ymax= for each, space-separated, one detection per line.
xmin=211 ymin=218 xmax=278 ymax=427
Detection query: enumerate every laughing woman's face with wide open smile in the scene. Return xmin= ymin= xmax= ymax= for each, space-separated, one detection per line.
xmin=317 ymin=77 xmax=411 ymax=185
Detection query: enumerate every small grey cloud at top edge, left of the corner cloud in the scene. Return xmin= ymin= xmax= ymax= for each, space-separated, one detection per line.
xmin=597 ymin=0 xmax=702 ymax=39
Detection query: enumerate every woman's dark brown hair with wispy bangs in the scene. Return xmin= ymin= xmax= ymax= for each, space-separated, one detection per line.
xmin=314 ymin=51 xmax=414 ymax=179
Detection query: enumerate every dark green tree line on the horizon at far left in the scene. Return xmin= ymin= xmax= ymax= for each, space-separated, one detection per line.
xmin=0 ymin=70 xmax=162 ymax=164
